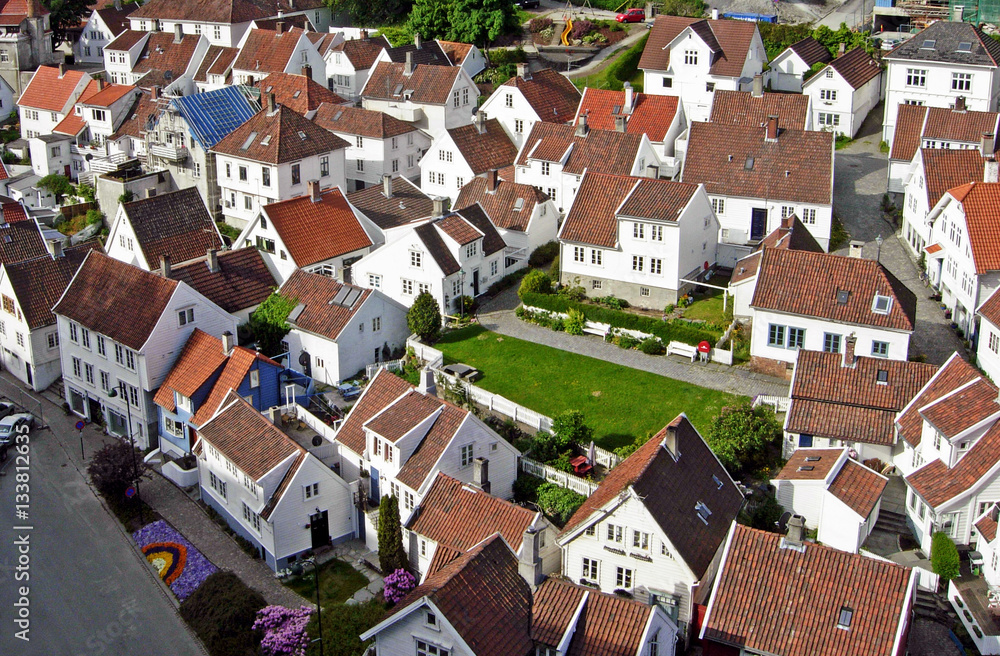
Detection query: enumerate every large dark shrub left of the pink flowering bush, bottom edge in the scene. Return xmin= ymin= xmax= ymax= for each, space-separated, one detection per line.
xmin=180 ymin=571 xmax=267 ymax=656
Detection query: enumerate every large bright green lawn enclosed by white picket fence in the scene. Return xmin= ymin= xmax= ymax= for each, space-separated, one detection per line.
xmin=435 ymin=326 xmax=738 ymax=449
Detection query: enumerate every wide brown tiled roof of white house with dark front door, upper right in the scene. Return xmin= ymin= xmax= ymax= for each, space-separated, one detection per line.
xmin=683 ymin=119 xmax=833 ymax=205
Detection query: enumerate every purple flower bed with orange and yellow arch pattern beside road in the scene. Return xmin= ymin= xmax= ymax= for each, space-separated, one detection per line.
xmin=132 ymin=519 xmax=218 ymax=601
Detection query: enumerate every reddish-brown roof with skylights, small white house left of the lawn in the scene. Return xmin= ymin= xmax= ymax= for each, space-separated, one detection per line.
xmin=281 ymin=269 xmax=372 ymax=340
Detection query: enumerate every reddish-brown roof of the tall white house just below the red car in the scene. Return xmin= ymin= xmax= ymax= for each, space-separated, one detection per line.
xmin=639 ymin=15 xmax=757 ymax=77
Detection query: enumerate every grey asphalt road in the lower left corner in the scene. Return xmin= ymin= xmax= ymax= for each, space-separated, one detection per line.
xmin=0 ymin=380 xmax=205 ymax=656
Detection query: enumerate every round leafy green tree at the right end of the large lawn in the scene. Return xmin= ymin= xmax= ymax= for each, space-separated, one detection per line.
xmin=708 ymin=402 xmax=781 ymax=474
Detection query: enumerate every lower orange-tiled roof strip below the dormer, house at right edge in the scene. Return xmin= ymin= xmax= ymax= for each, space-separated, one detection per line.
xmin=906 ymin=422 xmax=1000 ymax=508
